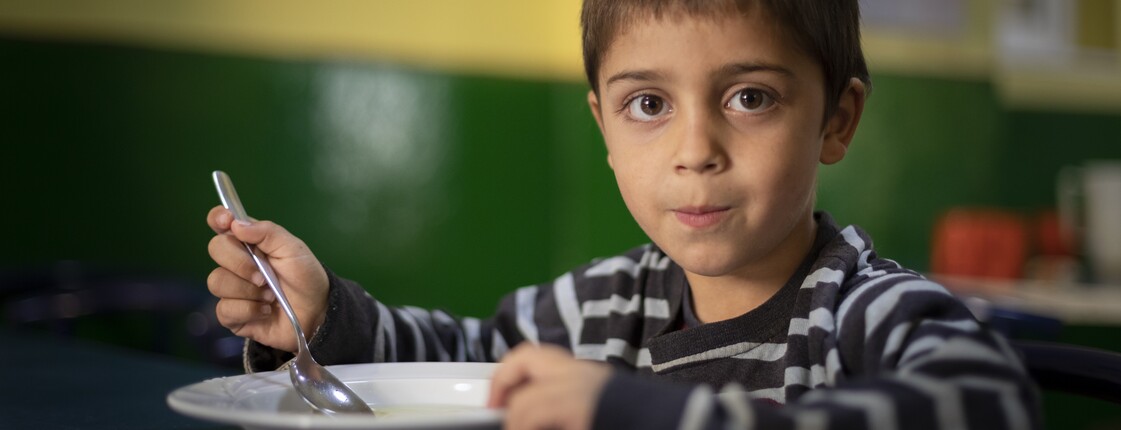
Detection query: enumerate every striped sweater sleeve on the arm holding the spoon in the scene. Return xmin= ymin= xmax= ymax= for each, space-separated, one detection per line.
xmin=244 ymin=246 xmax=666 ymax=372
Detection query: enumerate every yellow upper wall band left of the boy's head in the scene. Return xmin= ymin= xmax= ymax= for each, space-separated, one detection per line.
xmin=0 ymin=0 xmax=583 ymax=80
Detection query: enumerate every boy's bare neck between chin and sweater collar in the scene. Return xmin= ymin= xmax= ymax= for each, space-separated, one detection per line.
xmin=685 ymin=216 xmax=817 ymax=323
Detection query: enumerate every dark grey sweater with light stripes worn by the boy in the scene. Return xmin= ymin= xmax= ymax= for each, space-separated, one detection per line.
xmin=245 ymin=213 xmax=1040 ymax=429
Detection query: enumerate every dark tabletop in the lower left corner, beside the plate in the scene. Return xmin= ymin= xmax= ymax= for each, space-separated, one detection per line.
xmin=0 ymin=327 xmax=238 ymax=429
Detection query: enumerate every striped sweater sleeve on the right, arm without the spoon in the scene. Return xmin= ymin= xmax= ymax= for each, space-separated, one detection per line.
xmin=594 ymin=279 xmax=1041 ymax=430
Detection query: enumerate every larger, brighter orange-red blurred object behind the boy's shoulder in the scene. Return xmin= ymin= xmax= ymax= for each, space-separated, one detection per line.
xmin=930 ymin=208 xmax=1028 ymax=279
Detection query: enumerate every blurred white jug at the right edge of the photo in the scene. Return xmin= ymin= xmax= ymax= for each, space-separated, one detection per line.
xmin=1058 ymin=160 xmax=1121 ymax=286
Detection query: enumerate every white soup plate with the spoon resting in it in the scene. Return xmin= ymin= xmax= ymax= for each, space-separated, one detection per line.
xmin=167 ymin=363 xmax=502 ymax=430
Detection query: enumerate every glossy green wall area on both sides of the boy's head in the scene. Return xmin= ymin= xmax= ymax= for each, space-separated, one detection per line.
xmin=0 ymin=38 xmax=1121 ymax=315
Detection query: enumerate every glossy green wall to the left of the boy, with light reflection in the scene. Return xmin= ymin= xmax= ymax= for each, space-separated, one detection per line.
xmin=0 ymin=35 xmax=641 ymax=315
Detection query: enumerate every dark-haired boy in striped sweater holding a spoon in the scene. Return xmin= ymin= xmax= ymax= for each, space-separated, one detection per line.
xmin=207 ymin=0 xmax=1038 ymax=429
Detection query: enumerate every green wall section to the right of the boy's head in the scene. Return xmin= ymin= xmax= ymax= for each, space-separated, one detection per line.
xmin=818 ymin=75 xmax=1121 ymax=270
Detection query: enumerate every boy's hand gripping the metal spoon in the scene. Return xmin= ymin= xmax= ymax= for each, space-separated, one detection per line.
xmin=206 ymin=206 xmax=327 ymax=352
